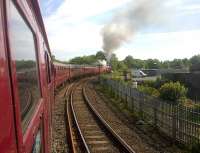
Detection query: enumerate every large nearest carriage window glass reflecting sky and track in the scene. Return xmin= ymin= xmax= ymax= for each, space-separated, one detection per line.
xmin=8 ymin=0 xmax=41 ymax=132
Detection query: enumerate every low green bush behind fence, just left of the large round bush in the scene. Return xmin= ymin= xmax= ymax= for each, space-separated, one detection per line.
xmin=138 ymin=85 xmax=160 ymax=97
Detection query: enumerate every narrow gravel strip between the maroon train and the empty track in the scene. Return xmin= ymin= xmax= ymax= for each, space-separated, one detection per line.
xmin=51 ymin=87 xmax=68 ymax=153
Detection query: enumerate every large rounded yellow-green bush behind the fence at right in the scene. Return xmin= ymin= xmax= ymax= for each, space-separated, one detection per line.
xmin=159 ymin=82 xmax=187 ymax=103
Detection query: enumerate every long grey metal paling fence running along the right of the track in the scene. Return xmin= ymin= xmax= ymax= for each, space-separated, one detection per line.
xmin=100 ymin=78 xmax=200 ymax=144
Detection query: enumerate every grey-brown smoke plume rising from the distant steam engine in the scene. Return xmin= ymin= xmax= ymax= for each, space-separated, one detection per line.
xmin=102 ymin=0 xmax=166 ymax=61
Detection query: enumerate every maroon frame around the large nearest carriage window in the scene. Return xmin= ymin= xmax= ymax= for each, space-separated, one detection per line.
xmin=6 ymin=0 xmax=43 ymax=133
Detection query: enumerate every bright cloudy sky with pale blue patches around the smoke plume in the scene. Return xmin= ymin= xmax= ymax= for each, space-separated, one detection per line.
xmin=40 ymin=0 xmax=200 ymax=60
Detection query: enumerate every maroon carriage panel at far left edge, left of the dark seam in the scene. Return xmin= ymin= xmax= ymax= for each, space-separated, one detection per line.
xmin=0 ymin=0 xmax=17 ymax=153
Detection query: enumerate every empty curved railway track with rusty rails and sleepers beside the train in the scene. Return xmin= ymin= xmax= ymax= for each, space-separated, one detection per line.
xmin=66 ymin=81 xmax=135 ymax=153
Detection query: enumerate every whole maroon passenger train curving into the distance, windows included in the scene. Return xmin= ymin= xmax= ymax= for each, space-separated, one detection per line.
xmin=0 ymin=0 xmax=109 ymax=153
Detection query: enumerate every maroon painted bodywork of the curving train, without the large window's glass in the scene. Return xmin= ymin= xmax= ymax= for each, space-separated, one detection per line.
xmin=0 ymin=0 xmax=109 ymax=153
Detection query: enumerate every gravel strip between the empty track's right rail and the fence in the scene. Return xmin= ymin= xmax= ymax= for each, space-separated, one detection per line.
xmin=86 ymin=84 xmax=187 ymax=153
